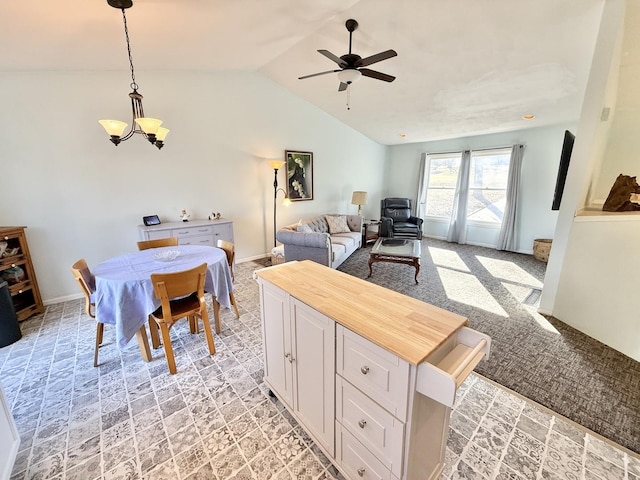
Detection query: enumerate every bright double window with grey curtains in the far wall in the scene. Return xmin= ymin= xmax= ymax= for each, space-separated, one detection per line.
xmin=425 ymin=148 xmax=511 ymax=225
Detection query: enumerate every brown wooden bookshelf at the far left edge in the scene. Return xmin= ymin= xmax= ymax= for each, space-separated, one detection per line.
xmin=0 ymin=227 xmax=44 ymax=321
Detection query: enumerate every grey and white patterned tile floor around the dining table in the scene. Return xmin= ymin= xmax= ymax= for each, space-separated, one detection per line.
xmin=0 ymin=262 xmax=640 ymax=480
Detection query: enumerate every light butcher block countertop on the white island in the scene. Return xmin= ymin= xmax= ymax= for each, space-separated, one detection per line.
xmin=255 ymin=260 xmax=467 ymax=365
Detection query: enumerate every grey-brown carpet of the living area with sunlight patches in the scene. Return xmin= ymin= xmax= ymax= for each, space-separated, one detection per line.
xmin=339 ymin=239 xmax=640 ymax=453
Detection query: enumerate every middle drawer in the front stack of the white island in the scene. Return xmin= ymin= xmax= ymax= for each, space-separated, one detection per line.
xmin=336 ymin=376 xmax=404 ymax=477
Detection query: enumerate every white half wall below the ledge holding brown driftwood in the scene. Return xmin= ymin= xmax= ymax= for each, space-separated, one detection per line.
xmin=553 ymin=216 xmax=640 ymax=361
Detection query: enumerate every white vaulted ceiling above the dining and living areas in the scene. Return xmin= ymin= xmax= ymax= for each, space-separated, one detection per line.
xmin=0 ymin=0 xmax=604 ymax=145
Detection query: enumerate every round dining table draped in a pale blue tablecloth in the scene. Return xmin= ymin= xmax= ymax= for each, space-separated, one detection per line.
xmin=92 ymin=245 xmax=233 ymax=361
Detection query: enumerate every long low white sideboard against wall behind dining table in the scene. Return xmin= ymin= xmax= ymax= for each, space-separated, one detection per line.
xmin=138 ymin=219 xmax=233 ymax=247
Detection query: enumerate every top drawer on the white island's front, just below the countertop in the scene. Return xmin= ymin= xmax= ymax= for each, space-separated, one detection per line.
xmin=336 ymin=325 xmax=409 ymax=422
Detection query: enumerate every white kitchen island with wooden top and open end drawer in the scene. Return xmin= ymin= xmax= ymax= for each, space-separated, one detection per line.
xmin=255 ymin=261 xmax=491 ymax=480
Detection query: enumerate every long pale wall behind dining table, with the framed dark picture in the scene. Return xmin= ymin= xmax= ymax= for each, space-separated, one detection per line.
xmin=0 ymin=72 xmax=386 ymax=301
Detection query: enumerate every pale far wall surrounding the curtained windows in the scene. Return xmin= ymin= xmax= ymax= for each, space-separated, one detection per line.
xmin=385 ymin=124 xmax=576 ymax=253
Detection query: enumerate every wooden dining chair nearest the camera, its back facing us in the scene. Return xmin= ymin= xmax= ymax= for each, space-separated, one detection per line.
xmin=149 ymin=263 xmax=216 ymax=374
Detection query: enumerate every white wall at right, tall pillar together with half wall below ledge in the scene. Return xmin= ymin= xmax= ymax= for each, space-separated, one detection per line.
xmin=540 ymin=0 xmax=640 ymax=361
